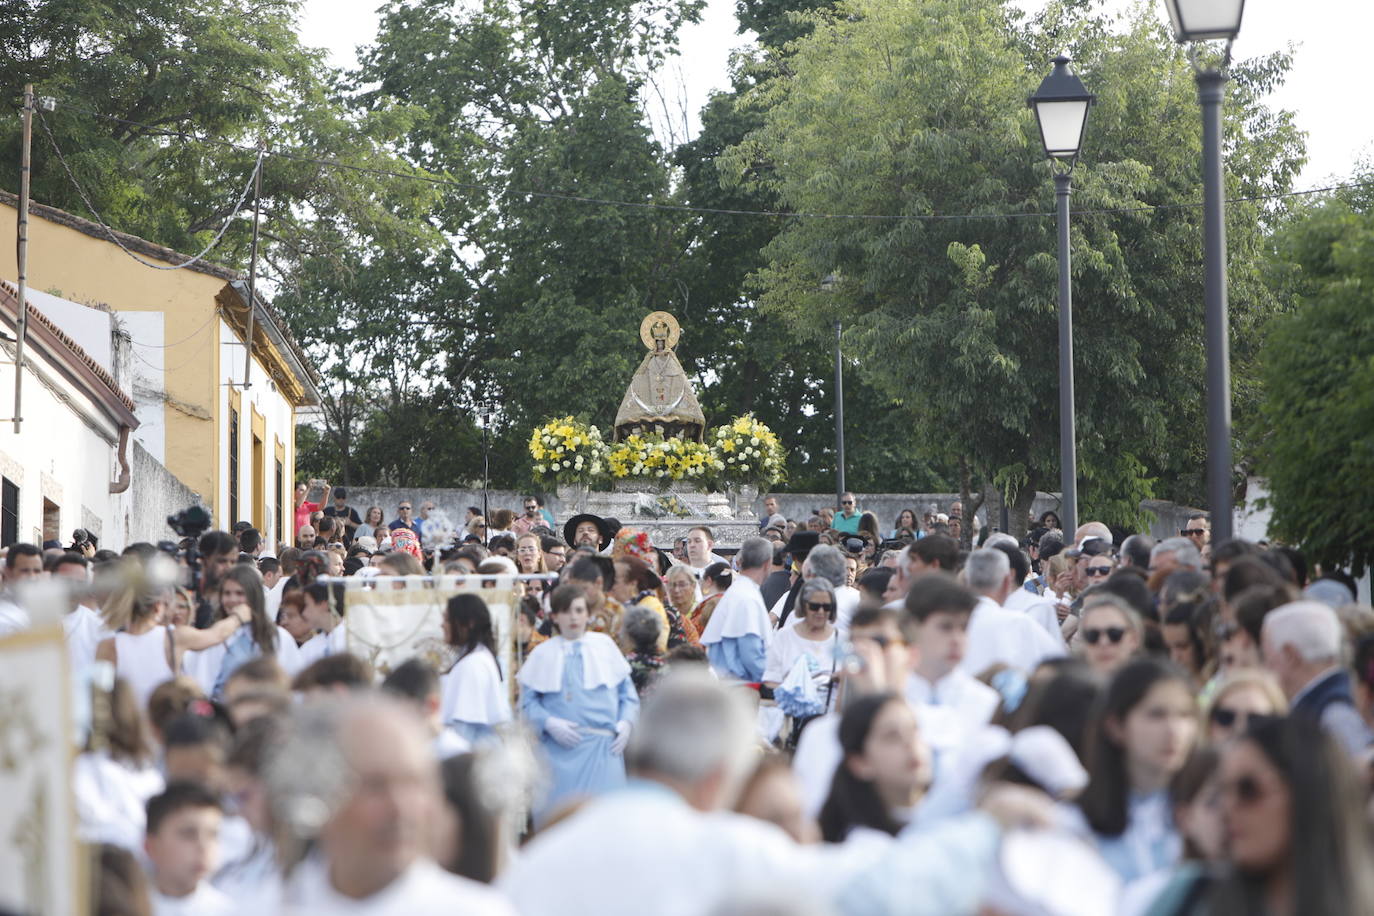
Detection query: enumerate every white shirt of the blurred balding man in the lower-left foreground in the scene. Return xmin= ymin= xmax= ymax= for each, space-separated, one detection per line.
xmin=280 ymin=858 xmax=515 ymax=916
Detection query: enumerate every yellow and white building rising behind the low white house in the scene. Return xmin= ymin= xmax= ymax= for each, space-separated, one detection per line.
xmin=0 ymin=194 xmax=319 ymax=542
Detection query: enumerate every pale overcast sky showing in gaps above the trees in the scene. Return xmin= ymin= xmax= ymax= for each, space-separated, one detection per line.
xmin=301 ymin=0 xmax=1374 ymax=188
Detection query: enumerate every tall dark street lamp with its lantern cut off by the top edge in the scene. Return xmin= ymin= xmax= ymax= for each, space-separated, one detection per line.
xmin=1164 ymin=0 xmax=1245 ymax=541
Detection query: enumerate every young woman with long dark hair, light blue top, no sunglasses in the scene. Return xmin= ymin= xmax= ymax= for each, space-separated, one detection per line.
xmin=1079 ymin=658 xmax=1198 ymax=882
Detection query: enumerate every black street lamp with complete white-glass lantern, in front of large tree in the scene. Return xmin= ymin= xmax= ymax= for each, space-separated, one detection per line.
xmin=1026 ymin=54 xmax=1095 ymax=536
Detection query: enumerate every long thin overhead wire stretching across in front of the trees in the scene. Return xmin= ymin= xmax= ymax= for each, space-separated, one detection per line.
xmin=49 ymin=107 xmax=1374 ymax=222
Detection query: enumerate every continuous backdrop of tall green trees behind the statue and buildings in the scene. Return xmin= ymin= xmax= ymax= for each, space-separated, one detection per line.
xmin=0 ymin=0 xmax=1335 ymax=532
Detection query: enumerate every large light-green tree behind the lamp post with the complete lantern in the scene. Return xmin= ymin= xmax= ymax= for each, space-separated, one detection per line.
xmin=723 ymin=0 xmax=1303 ymax=525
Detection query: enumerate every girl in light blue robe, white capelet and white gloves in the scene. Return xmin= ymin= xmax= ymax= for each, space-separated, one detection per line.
xmin=517 ymin=584 xmax=639 ymax=825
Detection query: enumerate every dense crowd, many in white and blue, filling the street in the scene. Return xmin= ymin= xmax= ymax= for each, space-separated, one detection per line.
xmin=0 ymin=481 xmax=1374 ymax=916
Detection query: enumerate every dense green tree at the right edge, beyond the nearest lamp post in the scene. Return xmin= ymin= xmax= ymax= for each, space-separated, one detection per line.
xmin=1256 ymin=178 xmax=1374 ymax=575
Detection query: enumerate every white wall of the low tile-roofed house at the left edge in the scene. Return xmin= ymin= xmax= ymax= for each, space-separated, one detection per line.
xmin=0 ymin=343 xmax=124 ymax=549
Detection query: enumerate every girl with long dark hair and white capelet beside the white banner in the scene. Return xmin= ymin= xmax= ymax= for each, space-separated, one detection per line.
xmin=440 ymin=593 xmax=511 ymax=746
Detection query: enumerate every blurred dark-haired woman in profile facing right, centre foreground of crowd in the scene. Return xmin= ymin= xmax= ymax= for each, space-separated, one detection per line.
xmin=820 ymin=694 xmax=930 ymax=843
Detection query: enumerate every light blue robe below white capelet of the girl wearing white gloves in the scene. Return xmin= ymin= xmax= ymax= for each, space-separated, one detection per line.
xmin=521 ymin=643 xmax=639 ymax=825
